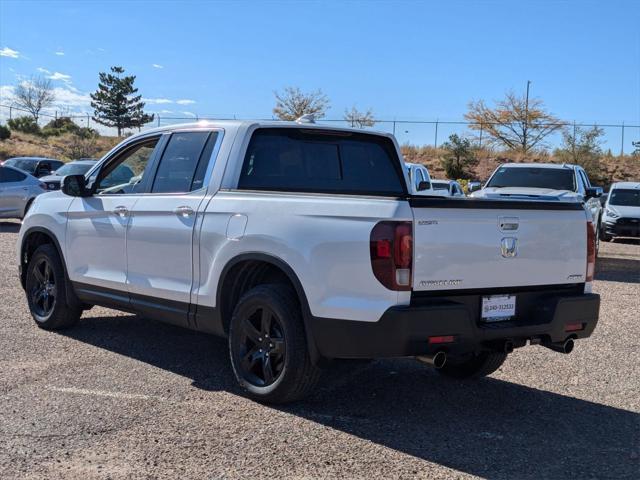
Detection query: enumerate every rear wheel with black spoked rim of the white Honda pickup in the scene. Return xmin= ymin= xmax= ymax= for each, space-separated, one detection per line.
xmin=229 ymin=284 xmax=320 ymax=403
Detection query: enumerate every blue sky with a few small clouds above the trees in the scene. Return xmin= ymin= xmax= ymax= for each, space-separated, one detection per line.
xmin=0 ymin=0 xmax=640 ymax=148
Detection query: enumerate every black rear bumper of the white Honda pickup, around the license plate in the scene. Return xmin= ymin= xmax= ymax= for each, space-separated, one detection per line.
xmin=309 ymin=294 xmax=600 ymax=358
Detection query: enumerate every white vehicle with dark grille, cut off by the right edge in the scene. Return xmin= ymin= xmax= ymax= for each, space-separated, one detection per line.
xmin=600 ymin=182 xmax=640 ymax=242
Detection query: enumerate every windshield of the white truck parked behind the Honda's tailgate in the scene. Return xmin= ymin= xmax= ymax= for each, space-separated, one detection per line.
xmin=487 ymin=167 xmax=575 ymax=191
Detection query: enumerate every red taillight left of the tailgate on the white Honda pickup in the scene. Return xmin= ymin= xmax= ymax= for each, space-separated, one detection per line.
xmin=370 ymin=221 xmax=413 ymax=290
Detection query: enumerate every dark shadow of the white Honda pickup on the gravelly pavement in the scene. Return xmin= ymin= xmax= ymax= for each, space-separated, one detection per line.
xmin=64 ymin=316 xmax=640 ymax=479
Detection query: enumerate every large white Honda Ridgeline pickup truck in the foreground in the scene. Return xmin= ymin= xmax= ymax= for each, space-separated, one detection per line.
xmin=18 ymin=121 xmax=599 ymax=402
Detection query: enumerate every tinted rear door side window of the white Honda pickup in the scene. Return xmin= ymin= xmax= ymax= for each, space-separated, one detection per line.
xmin=151 ymin=132 xmax=218 ymax=193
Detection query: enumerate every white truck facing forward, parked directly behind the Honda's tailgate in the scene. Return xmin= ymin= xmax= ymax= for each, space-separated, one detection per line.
xmin=471 ymin=163 xmax=602 ymax=252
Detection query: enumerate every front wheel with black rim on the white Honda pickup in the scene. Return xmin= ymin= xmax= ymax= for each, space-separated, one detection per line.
xmin=25 ymin=244 xmax=82 ymax=330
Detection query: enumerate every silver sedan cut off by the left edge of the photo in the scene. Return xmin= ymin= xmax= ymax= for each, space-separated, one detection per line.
xmin=0 ymin=165 xmax=45 ymax=218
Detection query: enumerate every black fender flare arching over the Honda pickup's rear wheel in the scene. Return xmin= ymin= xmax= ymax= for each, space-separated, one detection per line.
xmin=216 ymin=252 xmax=320 ymax=364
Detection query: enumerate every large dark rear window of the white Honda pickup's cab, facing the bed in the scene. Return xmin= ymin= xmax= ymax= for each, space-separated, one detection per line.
xmin=238 ymin=128 xmax=405 ymax=196
